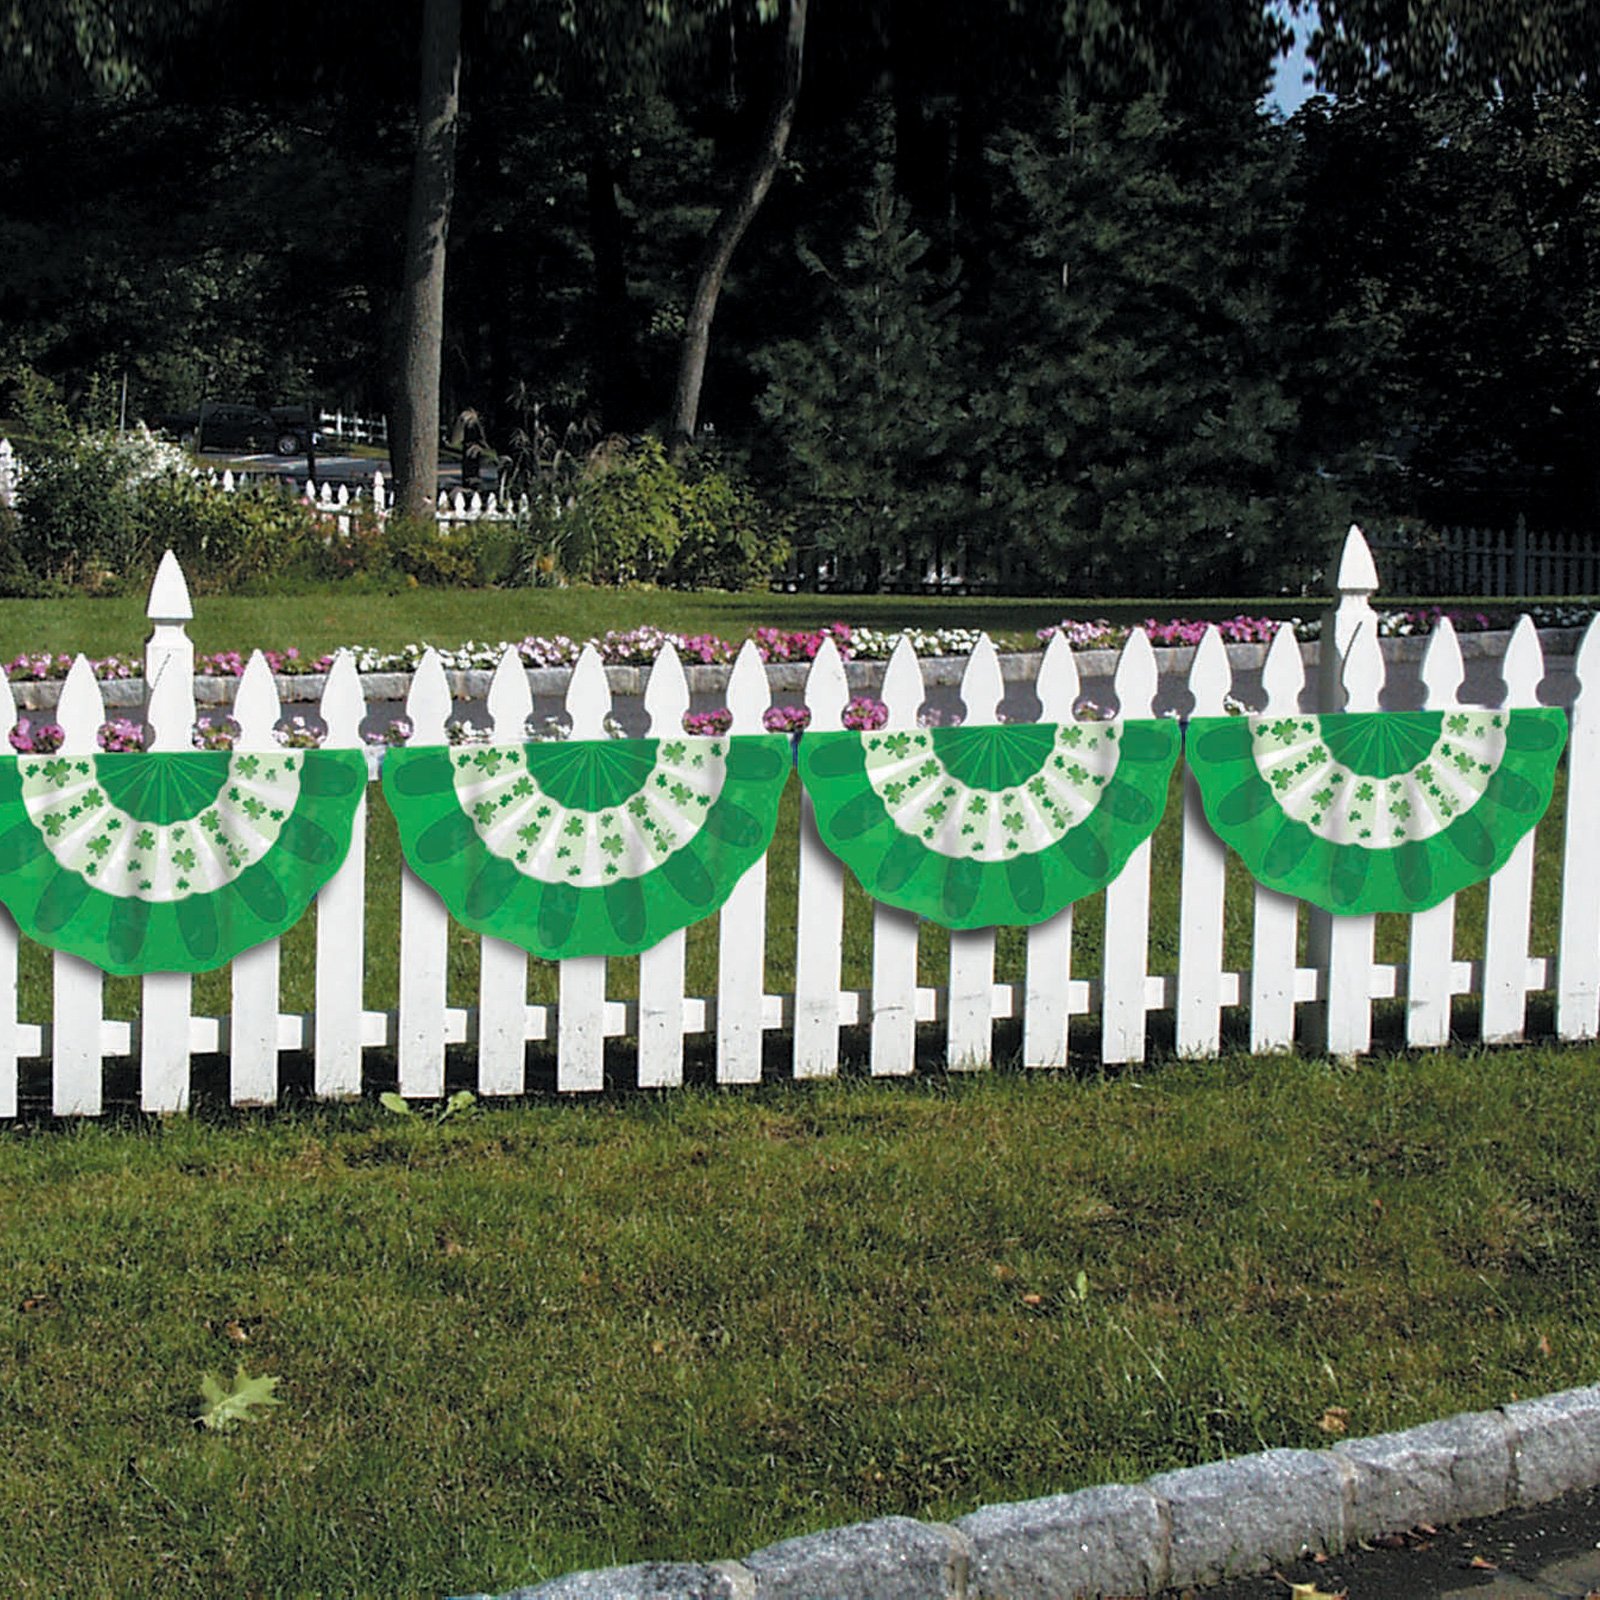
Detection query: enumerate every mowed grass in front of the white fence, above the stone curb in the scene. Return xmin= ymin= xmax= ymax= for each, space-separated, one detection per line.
xmin=0 ymin=1048 xmax=1600 ymax=1597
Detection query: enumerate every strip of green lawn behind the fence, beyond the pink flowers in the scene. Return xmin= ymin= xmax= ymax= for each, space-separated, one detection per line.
xmin=0 ymin=586 xmax=1325 ymax=659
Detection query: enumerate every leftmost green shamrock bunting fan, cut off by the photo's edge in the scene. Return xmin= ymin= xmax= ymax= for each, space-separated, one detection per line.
xmin=0 ymin=750 xmax=366 ymax=974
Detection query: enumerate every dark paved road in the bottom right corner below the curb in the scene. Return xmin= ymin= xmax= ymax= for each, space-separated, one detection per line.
xmin=1192 ymin=1490 xmax=1600 ymax=1600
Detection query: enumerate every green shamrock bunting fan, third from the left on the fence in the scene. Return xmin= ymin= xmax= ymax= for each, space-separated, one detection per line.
xmin=800 ymin=720 xmax=1178 ymax=928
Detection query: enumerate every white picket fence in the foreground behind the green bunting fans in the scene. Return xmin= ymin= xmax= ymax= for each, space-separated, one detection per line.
xmin=0 ymin=530 xmax=1600 ymax=1117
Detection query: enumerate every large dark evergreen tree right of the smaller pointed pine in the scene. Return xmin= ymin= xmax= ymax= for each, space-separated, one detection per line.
xmin=973 ymin=99 xmax=1336 ymax=594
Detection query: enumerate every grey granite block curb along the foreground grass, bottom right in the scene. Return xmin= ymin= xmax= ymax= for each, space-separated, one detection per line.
xmin=462 ymin=1387 xmax=1600 ymax=1600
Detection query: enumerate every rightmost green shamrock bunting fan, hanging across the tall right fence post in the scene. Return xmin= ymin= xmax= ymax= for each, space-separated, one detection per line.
xmin=1189 ymin=707 xmax=1566 ymax=915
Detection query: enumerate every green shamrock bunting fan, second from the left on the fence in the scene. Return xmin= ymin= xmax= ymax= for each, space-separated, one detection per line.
xmin=384 ymin=734 xmax=790 ymax=960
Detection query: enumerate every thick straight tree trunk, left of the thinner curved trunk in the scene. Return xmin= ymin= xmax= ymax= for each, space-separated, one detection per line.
xmin=389 ymin=0 xmax=461 ymax=517
